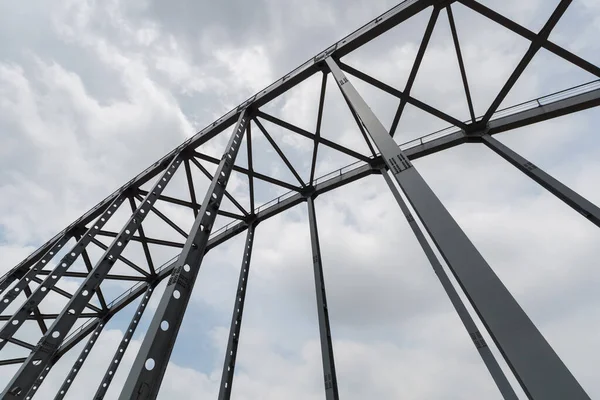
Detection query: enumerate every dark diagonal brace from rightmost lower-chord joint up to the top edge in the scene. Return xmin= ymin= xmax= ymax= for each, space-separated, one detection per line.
xmin=482 ymin=0 xmax=572 ymax=124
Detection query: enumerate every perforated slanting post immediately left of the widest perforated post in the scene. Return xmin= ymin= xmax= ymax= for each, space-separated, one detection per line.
xmin=1 ymin=154 xmax=181 ymax=400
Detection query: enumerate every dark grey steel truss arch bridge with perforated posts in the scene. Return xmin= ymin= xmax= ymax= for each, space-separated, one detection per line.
xmin=0 ymin=0 xmax=600 ymax=400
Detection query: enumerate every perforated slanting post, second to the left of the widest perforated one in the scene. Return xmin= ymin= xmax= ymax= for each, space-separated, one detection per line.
xmin=0 ymin=194 xmax=125 ymax=350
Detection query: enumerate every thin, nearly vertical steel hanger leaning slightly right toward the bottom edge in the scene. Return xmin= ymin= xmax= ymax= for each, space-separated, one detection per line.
xmin=307 ymin=197 xmax=340 ymax=400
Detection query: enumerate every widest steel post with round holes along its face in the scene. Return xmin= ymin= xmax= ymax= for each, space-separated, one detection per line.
xmin=119 ymin=109 xmax=249 ymax=400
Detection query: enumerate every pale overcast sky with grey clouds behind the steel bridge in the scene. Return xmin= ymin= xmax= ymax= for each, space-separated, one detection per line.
xmin=0 ymin=0 xmax=600 ymax=400
